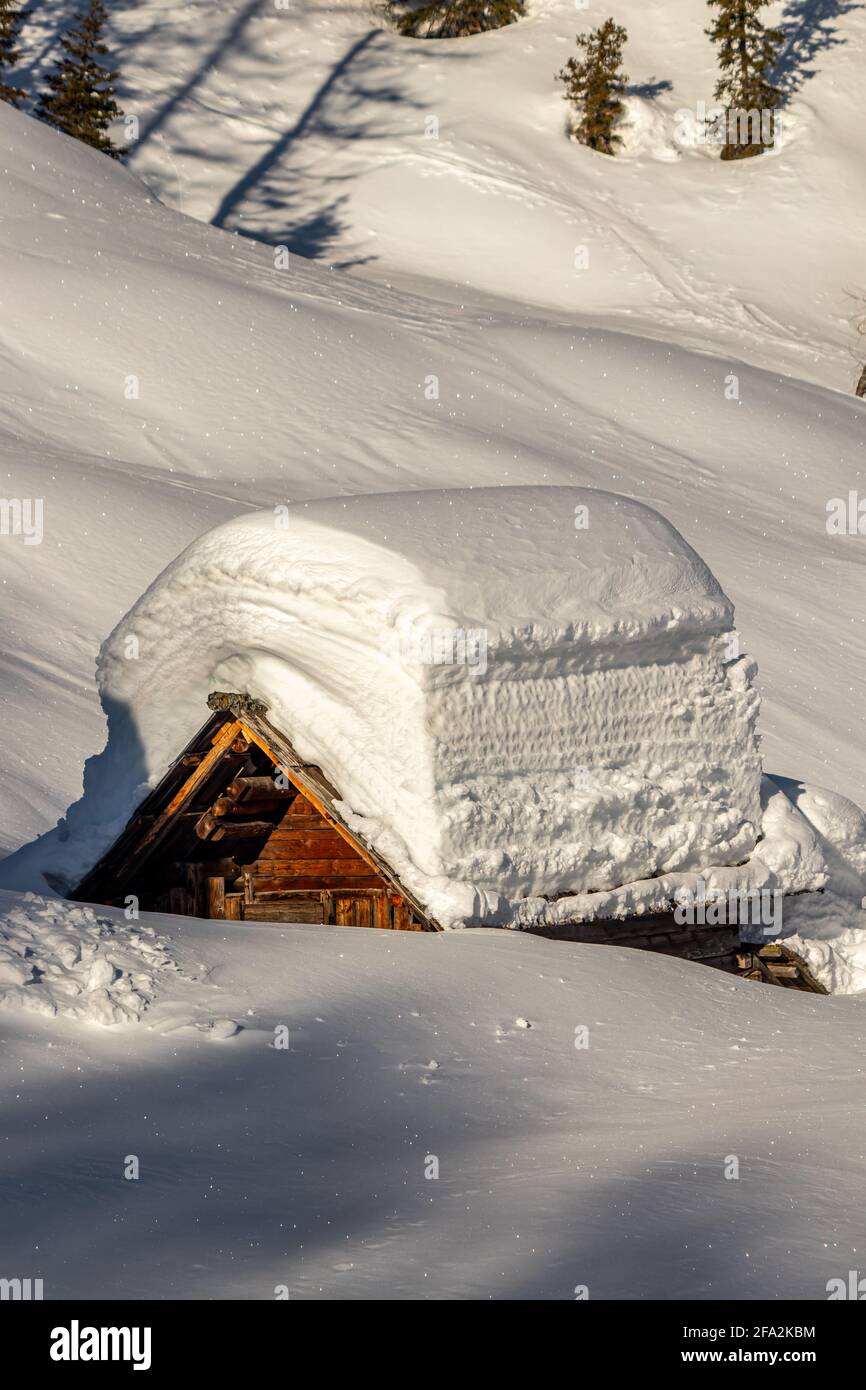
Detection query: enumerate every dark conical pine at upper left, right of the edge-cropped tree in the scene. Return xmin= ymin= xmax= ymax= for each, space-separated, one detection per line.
xmin=36 ymin=0 xmax=122 ymax=160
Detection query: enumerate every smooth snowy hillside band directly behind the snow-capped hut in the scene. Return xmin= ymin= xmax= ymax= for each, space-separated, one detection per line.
xmin=0 ymin=92 xmax=866 ymax=848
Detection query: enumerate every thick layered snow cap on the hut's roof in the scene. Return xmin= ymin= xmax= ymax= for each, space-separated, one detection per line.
xmin=38 ymin=487 xmax=760 ymax=924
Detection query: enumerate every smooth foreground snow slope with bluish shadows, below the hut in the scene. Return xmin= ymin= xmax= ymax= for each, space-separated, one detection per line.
xmin=0 ymin=895 xmax=866 ymax=1301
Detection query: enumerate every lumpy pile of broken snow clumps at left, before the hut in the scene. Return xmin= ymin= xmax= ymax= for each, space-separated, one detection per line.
xmin=0 ymin=892 xmax=177 ymax=1024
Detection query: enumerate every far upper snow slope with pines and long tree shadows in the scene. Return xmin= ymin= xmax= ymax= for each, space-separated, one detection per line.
xmin=20 ymin=0 xmax=866 ymax=389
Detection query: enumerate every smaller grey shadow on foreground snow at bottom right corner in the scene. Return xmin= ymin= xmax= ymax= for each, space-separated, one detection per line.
xmin=493 ymin=1150 xmax=866 ymax=1301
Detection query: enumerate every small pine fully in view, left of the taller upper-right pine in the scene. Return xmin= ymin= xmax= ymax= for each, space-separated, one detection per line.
xmin=556 ymin=19 xmax=628 ymax=154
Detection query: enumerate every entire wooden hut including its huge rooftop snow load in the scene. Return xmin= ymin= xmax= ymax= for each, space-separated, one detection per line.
xmin=53 ymin=487 xmax=815 ymax=929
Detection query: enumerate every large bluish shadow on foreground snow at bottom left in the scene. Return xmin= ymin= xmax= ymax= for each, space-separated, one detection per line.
xmin=0 ymin=967 xmax=547 ymax=1300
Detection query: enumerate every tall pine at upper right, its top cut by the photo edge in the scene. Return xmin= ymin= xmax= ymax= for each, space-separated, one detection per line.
xmin=706 ymin=0 xmax=784 ymax=160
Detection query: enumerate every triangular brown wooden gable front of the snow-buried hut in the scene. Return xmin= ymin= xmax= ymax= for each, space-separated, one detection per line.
xmin=72 ymin=696 xmax=438 ymax=931
